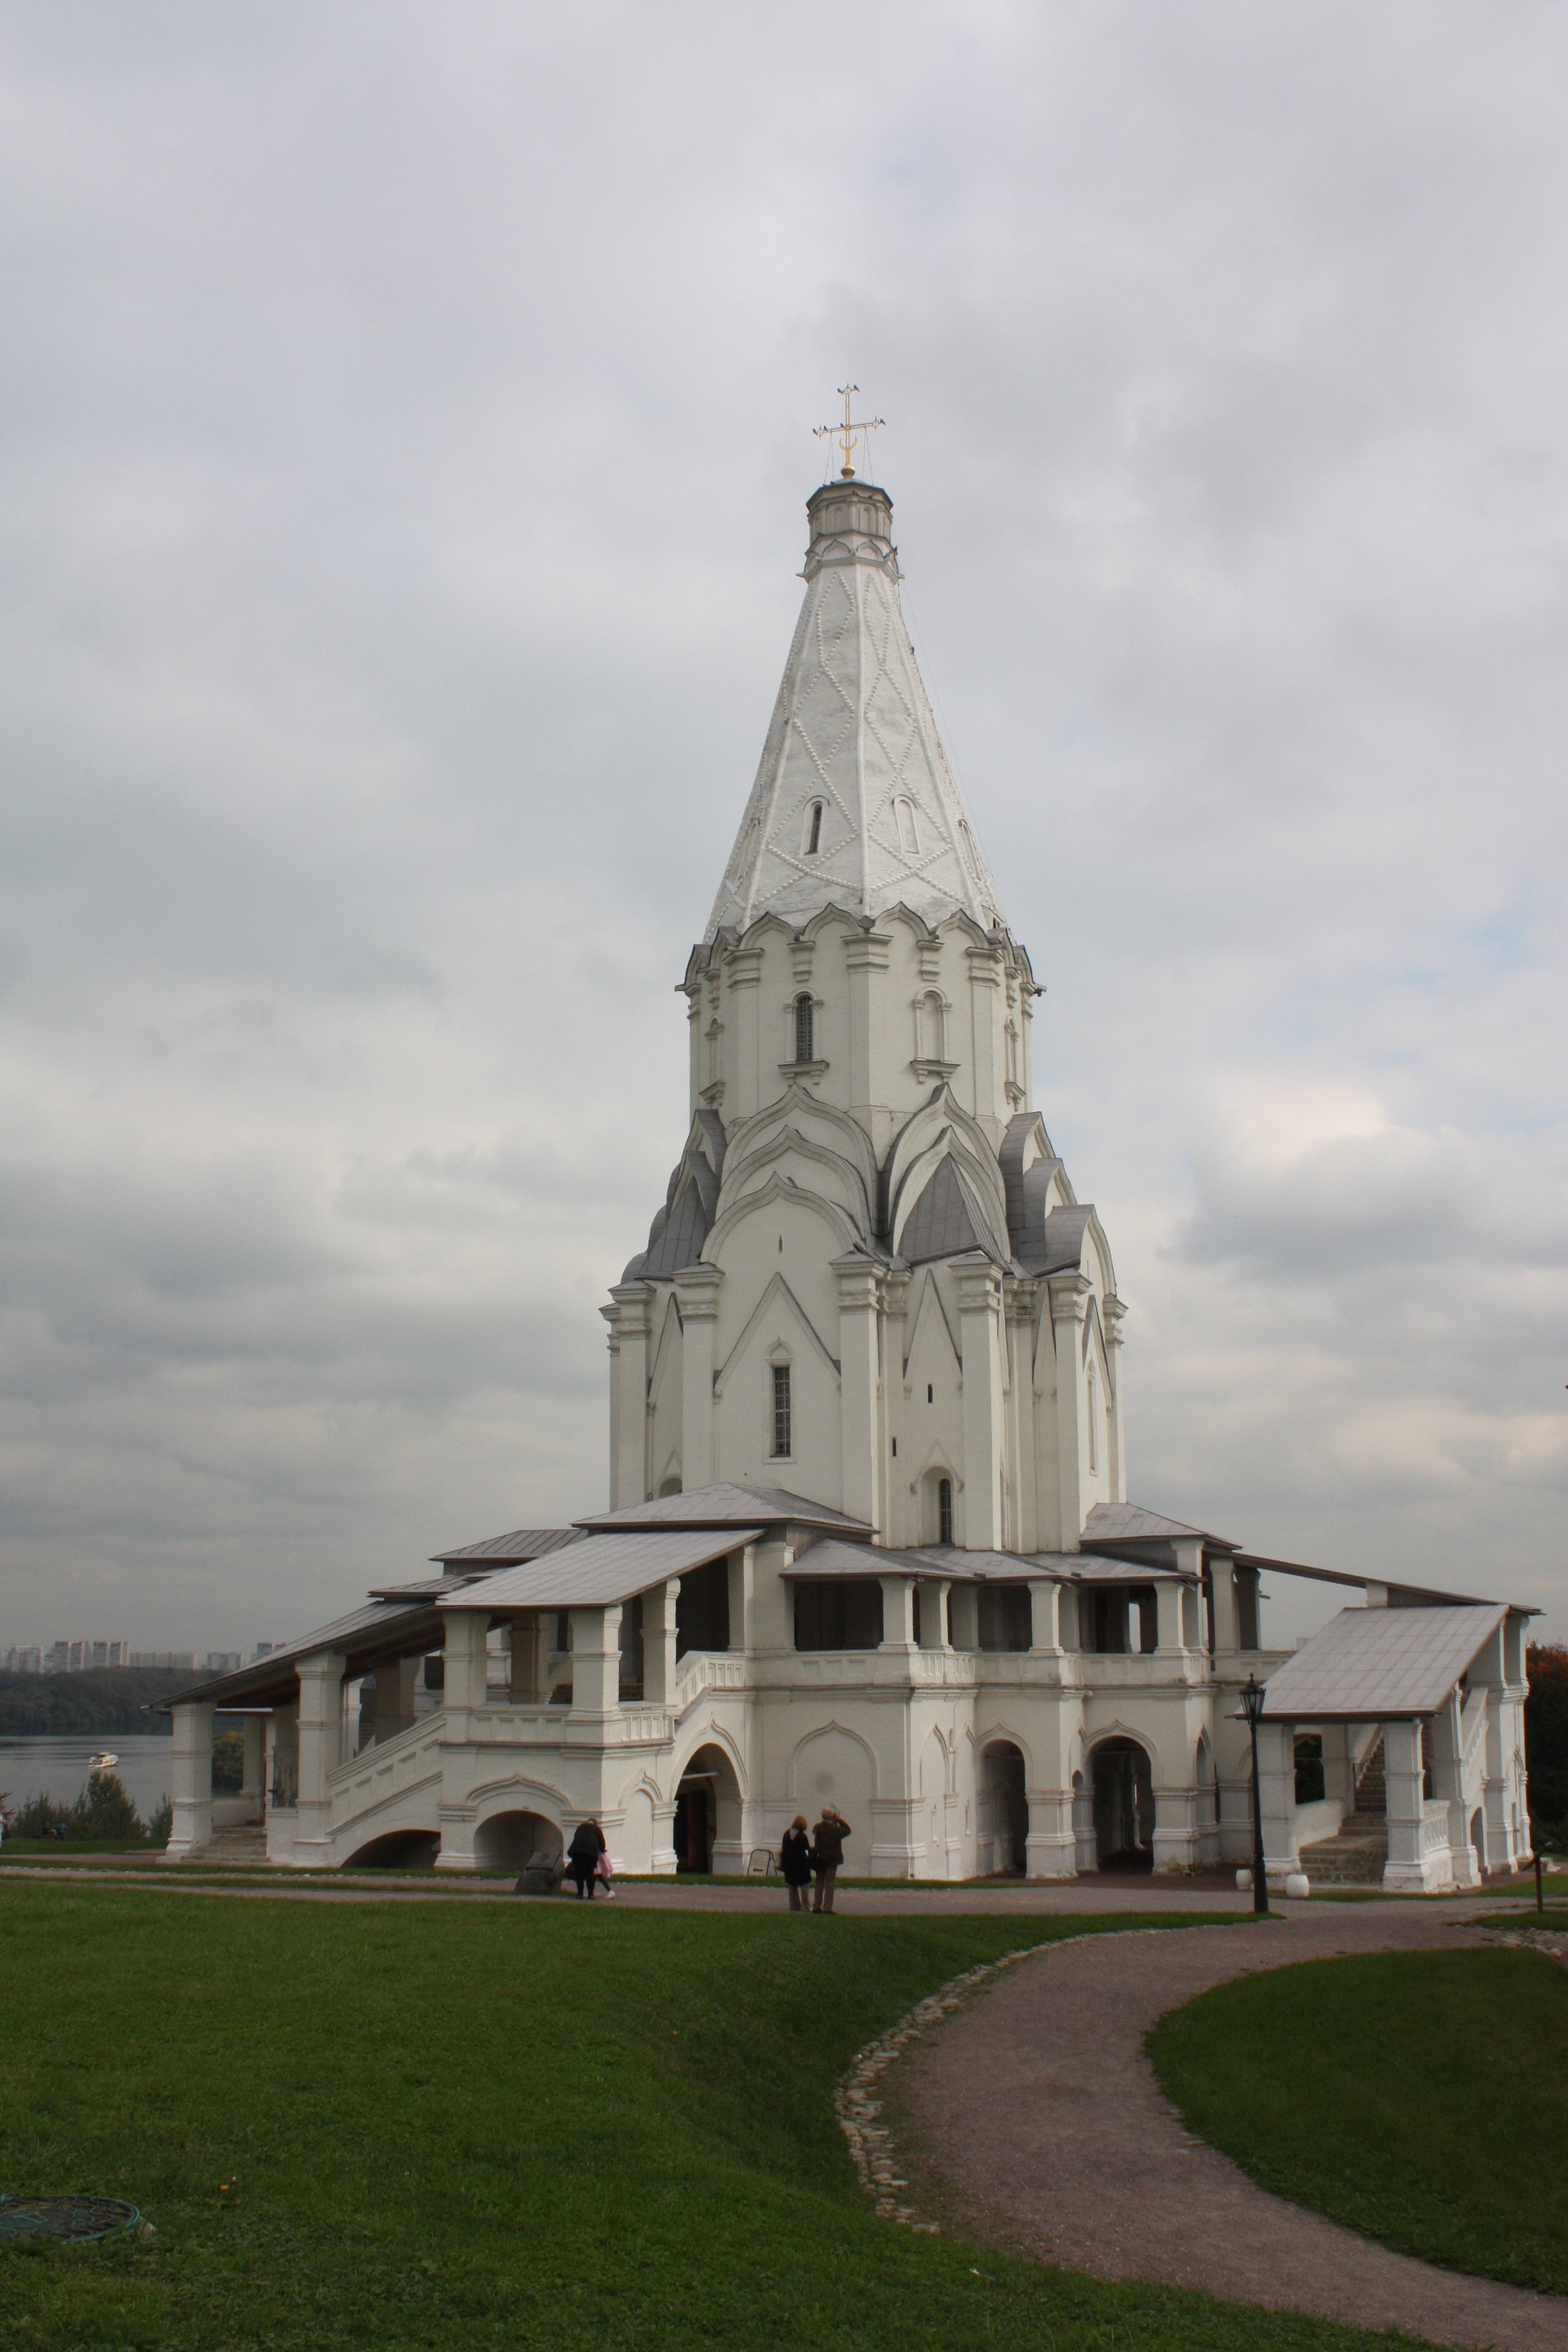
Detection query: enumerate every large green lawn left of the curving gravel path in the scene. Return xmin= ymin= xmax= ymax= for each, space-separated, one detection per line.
xmin=0 ymin=1879 xmax=1448 ymax=2352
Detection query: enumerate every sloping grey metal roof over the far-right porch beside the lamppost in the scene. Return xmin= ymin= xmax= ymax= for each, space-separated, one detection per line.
xmin=1262 ymin=1602 xmax=1507 ymax=1724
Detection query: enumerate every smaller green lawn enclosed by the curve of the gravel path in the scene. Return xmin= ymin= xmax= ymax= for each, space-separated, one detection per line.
xmin=1150 ymin=1947 xmax=1568 ymax=2293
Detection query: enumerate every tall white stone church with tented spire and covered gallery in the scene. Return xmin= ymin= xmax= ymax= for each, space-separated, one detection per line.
xmin=169 ymin=449 xmax=1528 ymax=1891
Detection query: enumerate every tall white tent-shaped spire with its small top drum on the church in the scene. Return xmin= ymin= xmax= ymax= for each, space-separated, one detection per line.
xmin=705 ymin=480 xmax=1004 ymax=939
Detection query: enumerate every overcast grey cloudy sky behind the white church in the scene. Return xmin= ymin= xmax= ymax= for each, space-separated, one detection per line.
xmin=0 ymin=0 xmax=1568 ymax=1651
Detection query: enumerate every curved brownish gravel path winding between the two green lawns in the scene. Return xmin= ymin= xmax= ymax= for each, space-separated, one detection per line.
xmin=900 ymin=1903 xmax=1568 ymax=2352
